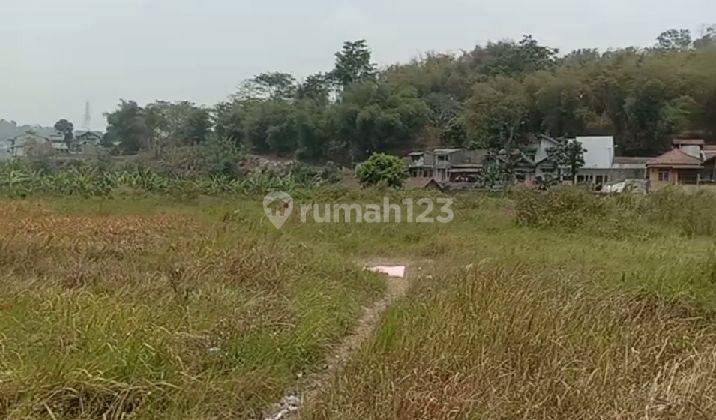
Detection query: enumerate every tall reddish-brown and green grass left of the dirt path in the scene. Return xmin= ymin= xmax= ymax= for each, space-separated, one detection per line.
xmin=0 ymin=202 xmax=381 ymax=419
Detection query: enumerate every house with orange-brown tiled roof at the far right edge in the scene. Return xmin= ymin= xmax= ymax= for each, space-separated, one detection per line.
xmin=646 ymin=139 xmax=716 ymax=189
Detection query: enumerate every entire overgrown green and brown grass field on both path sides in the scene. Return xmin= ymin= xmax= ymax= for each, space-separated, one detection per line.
xmin=0 ymin=190 xmax=716 ymax=419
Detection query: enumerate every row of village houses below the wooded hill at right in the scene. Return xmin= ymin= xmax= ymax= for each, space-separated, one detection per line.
xmin=408 ymin=136 xmax=716 ymax=191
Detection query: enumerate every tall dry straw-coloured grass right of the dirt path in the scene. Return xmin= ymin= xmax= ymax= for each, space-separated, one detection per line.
xmin=305 ymin=265 xmax=716 ymax=419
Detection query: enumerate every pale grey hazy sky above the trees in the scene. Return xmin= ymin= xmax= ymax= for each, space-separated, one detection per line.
xmin=0 ymin=0 xmax=716 ymax=129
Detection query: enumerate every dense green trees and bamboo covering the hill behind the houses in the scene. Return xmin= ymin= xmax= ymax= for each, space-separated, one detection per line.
xmin=104 ymin=25 xmax=716 ymax=164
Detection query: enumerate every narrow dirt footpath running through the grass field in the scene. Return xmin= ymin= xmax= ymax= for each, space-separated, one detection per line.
xmin=263 ymin=260 xmax=421 ymax=420
